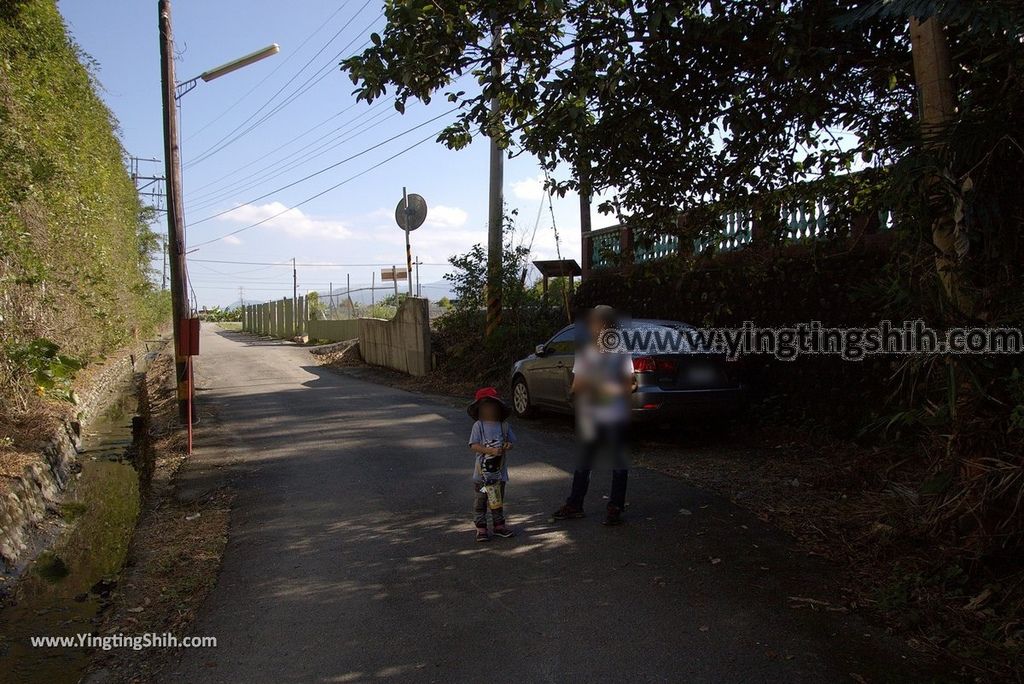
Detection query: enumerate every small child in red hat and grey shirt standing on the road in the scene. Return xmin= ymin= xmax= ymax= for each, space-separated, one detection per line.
xmin=467 ymin=387 xmax=515 ymax=542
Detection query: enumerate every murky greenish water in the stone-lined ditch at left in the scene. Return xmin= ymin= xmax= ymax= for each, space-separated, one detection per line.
xmin=0 ymin=374 xmax=139 ymax=684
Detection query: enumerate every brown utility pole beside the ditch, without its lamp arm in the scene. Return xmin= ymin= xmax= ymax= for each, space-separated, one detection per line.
xmin=159 ymin=0 xmax=191 ymax=422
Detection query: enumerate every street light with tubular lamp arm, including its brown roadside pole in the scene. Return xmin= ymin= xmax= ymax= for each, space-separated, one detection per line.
xmin=158 ymin=0 xmax=281 ymax=432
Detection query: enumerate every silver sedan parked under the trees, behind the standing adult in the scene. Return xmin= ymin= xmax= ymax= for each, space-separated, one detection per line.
xmin=511 ymin=318 xmax=744 ymax=421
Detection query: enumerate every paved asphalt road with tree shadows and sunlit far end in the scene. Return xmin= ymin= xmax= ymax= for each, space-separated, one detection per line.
xmin=166 ymin=326 xmax=921 ymax=683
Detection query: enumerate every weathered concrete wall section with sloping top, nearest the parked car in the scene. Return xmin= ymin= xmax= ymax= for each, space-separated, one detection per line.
xmin=357 ymin=297 xmax=430 ymax=376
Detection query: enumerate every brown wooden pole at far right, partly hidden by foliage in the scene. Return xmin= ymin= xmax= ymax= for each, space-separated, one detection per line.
xmin=910 ymin=16 xmax=970 ymax=312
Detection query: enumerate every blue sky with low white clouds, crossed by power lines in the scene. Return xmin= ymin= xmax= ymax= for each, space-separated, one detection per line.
xmin=58 ymin=0 xmax=609 ymax=305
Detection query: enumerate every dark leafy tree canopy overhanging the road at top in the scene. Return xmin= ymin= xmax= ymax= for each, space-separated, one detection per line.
xmin=344 ymin=0 xmax=913 ymax=228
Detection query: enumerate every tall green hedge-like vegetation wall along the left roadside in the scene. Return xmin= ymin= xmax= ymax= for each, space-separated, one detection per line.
xmin=0 ymin=0 xmax=169 ymax=424
